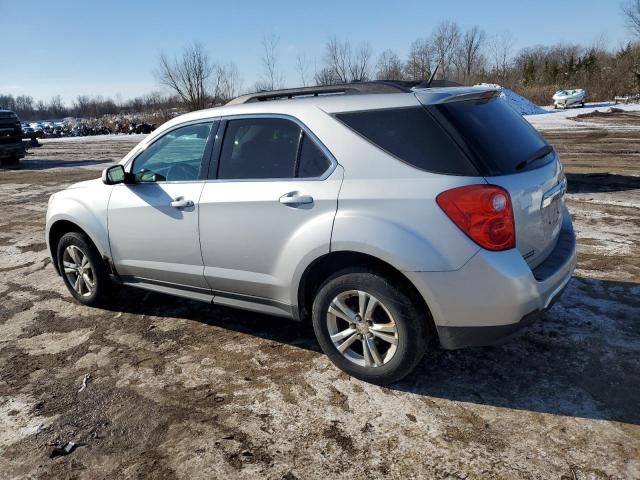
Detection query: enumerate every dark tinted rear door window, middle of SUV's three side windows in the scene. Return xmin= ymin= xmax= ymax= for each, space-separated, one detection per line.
xmin=218 ymin=118 xmax=331 ymax=180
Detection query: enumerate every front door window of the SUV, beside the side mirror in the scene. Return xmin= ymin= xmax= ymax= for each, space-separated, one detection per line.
xmin=131 ymin=122 xmax=214 ymax=182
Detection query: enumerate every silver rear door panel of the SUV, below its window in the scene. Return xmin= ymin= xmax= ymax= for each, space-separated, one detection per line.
xmin=200 ymin=166 xmax=343 ymax=304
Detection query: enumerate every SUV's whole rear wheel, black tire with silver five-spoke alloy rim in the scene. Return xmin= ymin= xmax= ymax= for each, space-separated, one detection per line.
xmin=313 ymin=271 xmax=428 ymax=384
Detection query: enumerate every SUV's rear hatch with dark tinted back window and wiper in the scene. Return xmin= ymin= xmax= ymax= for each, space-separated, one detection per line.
xmin=416 ymin=89 xmax=566 ymax=268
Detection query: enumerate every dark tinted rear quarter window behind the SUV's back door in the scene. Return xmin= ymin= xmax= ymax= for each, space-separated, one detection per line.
xmin=336 ymin=107 xmax=478 ymax=176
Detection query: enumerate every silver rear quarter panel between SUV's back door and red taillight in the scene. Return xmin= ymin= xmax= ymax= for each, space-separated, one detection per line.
xmin=317 ymin=109 xmax=486 ymax=271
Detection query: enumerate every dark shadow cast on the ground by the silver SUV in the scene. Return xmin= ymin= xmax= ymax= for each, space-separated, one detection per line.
xmin=101 ymin=278 xmax=640 ymax=424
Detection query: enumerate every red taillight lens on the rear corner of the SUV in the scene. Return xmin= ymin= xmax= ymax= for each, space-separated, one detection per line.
xmin=436 ymin=185 xmax=516 ymax=250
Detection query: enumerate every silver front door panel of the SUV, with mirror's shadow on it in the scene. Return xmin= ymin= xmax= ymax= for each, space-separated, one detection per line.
xmin=108 ymin=181 xmax=208 ymax=288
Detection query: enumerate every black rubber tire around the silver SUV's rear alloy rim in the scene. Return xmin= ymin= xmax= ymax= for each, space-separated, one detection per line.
xmin=312 ymin=270 xmax=429 ymax=385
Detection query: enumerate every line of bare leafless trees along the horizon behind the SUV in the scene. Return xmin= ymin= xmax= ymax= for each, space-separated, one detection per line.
xmin=5 ymin=4 xmax=640 ymax=120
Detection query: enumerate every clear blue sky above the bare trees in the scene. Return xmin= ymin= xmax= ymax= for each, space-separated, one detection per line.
xmin=0 ymin=0 xmax=630 ymax=105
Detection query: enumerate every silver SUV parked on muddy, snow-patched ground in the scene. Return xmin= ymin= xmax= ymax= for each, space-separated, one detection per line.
xmin=46 ymin=85 xmax=576 ymax=384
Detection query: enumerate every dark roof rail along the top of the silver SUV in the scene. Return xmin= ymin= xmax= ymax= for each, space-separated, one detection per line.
xmin=227 ymin=80 xmax=430 ymax=105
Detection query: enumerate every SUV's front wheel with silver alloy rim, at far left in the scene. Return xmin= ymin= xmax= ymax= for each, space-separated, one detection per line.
xmin=57 ymin=232 xmax=111 ymax=306
